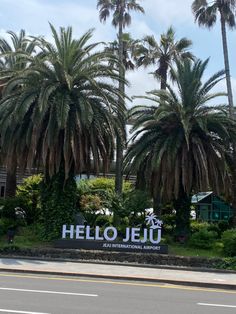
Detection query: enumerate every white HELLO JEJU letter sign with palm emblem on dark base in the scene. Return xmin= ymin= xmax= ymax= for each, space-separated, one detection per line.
xmin=55 ymin=213 xmax=168 ymax=253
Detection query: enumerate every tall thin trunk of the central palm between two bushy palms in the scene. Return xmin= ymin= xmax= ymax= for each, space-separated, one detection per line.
xmin=115 ymin=5 xmax=125 ymax=195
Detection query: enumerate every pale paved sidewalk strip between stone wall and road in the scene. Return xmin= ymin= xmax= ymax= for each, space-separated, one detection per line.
xmin=0 ymin=258 xmax=236 ymax=290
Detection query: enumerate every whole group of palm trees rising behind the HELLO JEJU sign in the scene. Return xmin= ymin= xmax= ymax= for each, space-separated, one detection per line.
xmin=0 ymin=0 xmax=236 ymax=233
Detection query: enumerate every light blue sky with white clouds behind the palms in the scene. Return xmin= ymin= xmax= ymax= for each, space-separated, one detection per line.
xmin=0 ymin=0 xmax=236 ymax=103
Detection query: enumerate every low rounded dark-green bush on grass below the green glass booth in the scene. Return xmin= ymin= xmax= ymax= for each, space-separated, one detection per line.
xmin=189 ymin=228 xmax=218 ymax=249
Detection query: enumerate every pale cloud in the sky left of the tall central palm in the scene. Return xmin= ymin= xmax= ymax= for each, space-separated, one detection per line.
xmin=1 ymin=0 xmax=114 ymax=41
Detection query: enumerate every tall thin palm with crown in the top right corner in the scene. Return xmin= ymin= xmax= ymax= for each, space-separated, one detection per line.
xmin=192 ymin=0 xmax=236 ymax=117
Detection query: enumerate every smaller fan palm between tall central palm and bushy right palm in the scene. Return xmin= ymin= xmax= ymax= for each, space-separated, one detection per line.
xmin=134 ymin=27 xmax=194 ymax=89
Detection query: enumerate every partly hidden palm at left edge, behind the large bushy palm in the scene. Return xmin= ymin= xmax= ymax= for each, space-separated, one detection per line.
xmin=0 ymin=30 xmax=35 ymax=196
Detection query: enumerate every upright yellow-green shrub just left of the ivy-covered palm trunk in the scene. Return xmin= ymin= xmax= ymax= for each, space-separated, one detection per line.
xmin=16 ymin=174 xmax=43 ymax=224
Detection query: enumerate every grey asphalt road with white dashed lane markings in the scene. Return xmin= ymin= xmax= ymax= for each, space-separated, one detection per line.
xmin=0 ymin=272 xmax=236 ymax=314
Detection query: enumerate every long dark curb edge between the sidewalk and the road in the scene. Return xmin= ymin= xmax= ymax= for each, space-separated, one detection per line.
xmin=0 ymin=267 xmax=236 ymax=290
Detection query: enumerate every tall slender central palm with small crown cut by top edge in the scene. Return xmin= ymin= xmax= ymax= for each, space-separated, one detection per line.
xmin=97 ymin=0 xmax=144 ymax=194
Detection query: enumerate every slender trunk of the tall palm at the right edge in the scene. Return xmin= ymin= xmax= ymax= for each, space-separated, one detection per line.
xmin=220 ymin=14 xmax=236 ymax=226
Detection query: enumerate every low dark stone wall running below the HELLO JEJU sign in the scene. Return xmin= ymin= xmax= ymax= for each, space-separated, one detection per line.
xmin=0 ymin=246 xmax=227 ymax=268
